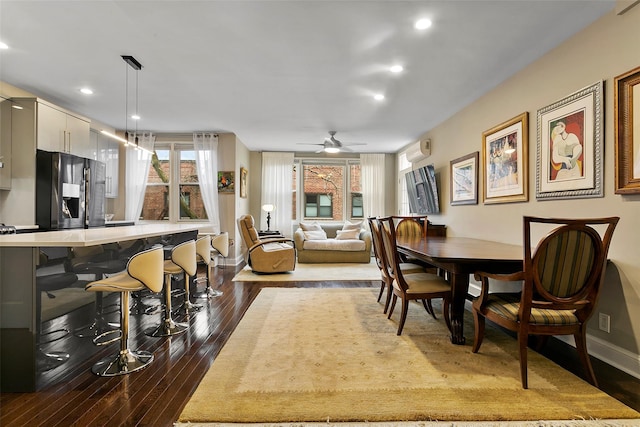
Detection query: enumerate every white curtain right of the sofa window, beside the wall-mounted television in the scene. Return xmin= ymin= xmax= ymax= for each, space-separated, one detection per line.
xmin=360 ymin=154 xmax=386 ymax=218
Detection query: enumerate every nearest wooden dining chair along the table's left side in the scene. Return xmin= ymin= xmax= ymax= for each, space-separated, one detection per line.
xmin=378 ymin=217 xmax=452 ymax=335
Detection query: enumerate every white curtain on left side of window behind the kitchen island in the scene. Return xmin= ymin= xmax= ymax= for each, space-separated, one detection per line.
xmin=124 ymin=132 xmax=156 ymax=221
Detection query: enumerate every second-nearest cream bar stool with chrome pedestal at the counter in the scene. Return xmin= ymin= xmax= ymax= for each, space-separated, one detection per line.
xmin=144 ymin=240 xmax=199 ymax=337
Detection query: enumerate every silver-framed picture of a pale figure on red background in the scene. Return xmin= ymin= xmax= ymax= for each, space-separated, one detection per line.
xmin=536 ymin=81 xmax=604 ymax=200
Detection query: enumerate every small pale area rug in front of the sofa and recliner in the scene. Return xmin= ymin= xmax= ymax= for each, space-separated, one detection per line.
xmin=233 ymin=260 xmax=380 ymax=282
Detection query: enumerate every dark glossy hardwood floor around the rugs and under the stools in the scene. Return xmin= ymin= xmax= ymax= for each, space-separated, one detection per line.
xmin=0 ymin=266 xmax=640 ymax=427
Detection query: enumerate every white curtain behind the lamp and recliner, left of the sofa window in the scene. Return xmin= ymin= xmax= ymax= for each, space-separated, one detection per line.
xmin=257 ymin=153 xmax=293 ymax=237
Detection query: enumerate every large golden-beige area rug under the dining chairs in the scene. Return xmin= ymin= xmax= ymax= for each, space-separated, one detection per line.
xmin=179 ymin=288 xmax=640 ymax=426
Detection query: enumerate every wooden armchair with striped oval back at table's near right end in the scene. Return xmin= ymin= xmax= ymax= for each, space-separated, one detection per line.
xmin=472 ymin=216 xmax=619 ymax=388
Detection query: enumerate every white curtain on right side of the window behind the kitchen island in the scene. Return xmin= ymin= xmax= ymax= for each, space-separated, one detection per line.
xmin=193 ymin=132 xmax=220 ymax=234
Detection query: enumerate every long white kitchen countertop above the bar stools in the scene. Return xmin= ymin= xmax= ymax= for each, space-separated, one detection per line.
xmin=0 ymin=222 xmax=210 ymax=247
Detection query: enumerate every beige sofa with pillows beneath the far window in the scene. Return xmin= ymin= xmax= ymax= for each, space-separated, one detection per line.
xmin=293 ymin=221 xmax=371 ymax=264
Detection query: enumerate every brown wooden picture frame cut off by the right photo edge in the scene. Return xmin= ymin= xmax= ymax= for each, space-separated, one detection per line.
xmin=613 ymin=67 xmax=640 ymax=194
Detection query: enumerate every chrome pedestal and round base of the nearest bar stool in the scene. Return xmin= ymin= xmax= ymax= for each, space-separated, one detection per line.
xmin=91 ymin=292 xmax=153 ymax=377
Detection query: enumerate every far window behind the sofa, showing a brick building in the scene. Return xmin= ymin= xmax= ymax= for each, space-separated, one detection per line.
xmin=293 ymin=159 xmax=364 ymax=221
